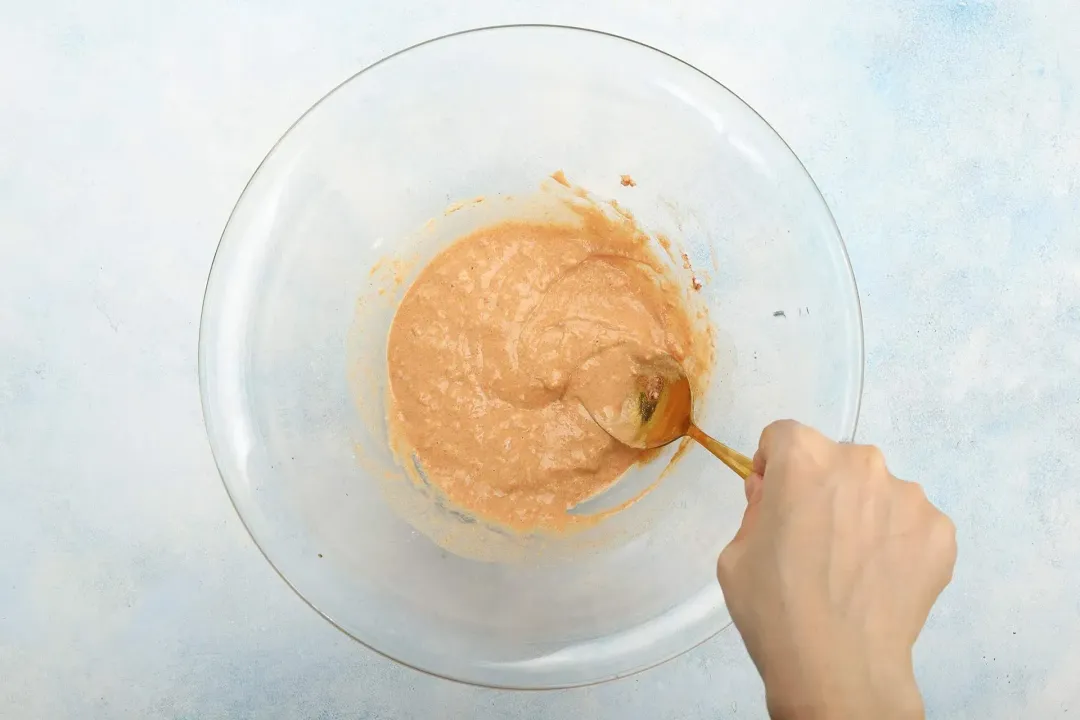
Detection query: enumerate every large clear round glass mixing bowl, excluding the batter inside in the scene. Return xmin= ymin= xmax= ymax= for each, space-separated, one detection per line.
xmin=199 ymin=26 xmax=863 ymax=688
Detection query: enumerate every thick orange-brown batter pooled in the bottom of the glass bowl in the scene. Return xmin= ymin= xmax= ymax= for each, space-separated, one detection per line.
xmin=387 ymin=188 xmax=711 ymax=531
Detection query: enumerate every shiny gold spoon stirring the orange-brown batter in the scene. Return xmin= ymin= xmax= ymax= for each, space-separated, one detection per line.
xmin=579 ymin=355 xmax=754 ymax=480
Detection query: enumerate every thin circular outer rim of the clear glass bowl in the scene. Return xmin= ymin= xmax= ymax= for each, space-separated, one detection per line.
xmin=198 ymin=23 xmax=866 ymax=692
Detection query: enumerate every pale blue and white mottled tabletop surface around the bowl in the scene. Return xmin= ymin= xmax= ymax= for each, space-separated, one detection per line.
xmin=0 ymin=0 xmax=1080 ymax=720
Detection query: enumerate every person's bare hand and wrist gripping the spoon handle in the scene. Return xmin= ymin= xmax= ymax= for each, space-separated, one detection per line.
xmin=716 ymin=420 xmax=956 ymax=720
